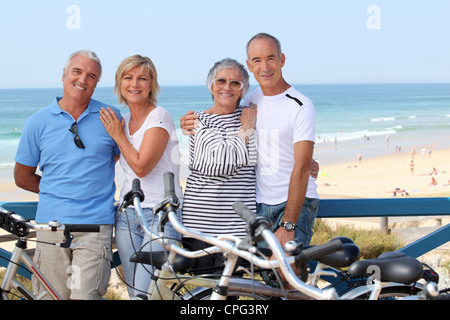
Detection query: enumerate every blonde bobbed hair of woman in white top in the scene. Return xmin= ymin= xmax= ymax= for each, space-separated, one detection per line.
xmin=114 ymin=54 xmax=161 ymax=105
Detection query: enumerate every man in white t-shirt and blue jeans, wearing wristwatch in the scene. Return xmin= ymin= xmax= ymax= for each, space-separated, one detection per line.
xmin=243 ymin=33 xmax=319 ymax=245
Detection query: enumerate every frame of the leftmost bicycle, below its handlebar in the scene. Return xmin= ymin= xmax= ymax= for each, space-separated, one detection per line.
xmin=1 ymin=238 xmax=62 ymax=300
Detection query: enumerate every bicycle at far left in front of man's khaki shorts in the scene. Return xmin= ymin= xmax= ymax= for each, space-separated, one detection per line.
xmin=0 ymin=206 xmax=99 ymax=300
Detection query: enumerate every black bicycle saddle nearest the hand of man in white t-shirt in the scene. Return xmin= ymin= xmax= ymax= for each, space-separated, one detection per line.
xmin=317 ymin=237 xmax=361 ymax=268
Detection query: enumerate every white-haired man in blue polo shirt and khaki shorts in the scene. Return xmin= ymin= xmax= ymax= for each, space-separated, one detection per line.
xmin=14 ymin=50 xmax=120 ymax=300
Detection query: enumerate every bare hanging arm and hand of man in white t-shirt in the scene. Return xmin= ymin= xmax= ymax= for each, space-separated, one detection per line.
xmin=276 ymin=141 xmax=314 ymax=246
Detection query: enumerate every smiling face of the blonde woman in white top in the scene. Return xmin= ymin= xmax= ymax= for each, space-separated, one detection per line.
xmin=120 ymin=66 xmax=152 ymax=104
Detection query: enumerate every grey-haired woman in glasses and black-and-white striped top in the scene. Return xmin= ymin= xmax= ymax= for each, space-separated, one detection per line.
xmin=183 ymin=59 xmax=256 ymax=266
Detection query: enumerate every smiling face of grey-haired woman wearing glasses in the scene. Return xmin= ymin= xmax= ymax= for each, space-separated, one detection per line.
xmin=212 ymin=68 xmax=242 ymax=110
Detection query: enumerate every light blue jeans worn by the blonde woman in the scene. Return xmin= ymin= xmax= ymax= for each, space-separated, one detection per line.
xmin=115 ymin=208 xmax=181 ymax=298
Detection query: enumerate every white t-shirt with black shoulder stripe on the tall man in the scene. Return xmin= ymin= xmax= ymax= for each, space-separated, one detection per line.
xmin=241 ymin=87 xmax=319 ymax=205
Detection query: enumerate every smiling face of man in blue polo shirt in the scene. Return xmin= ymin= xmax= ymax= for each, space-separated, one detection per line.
xmin=62 ymin=54 xmax=101 ymax=105
